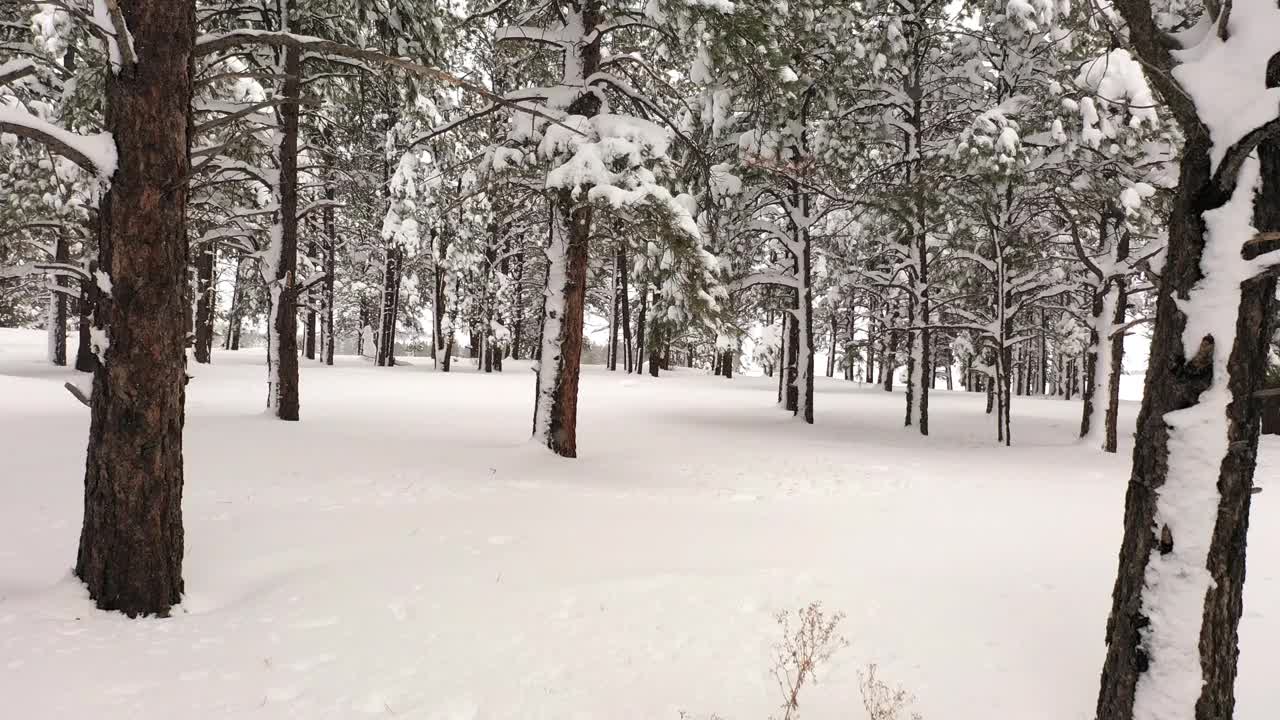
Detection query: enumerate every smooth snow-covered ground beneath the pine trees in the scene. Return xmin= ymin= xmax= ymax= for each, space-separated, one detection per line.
xmin=0 ymin=329 xmax=1280 ymax=720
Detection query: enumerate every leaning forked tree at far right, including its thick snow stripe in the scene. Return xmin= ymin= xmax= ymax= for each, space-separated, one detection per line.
xmin=1097 ymin=0 xmax=1280 ymax=720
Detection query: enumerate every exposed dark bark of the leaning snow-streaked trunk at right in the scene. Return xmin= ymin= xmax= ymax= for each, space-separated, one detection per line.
xmin=1097 ymin=68 xmax=1280 ymax=720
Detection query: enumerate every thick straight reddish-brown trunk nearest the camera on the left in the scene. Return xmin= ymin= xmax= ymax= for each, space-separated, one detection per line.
xmin=76 ymin=0 xmax=196 ymax=616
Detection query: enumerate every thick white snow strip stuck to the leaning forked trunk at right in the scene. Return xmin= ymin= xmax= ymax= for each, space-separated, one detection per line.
xmin=1134 ymin=0 xmax=1280 ymax=720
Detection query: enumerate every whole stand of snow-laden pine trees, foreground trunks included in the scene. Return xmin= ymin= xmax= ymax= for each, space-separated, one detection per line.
xmin=0 ymin=0 xmax=1280 ymax=717
